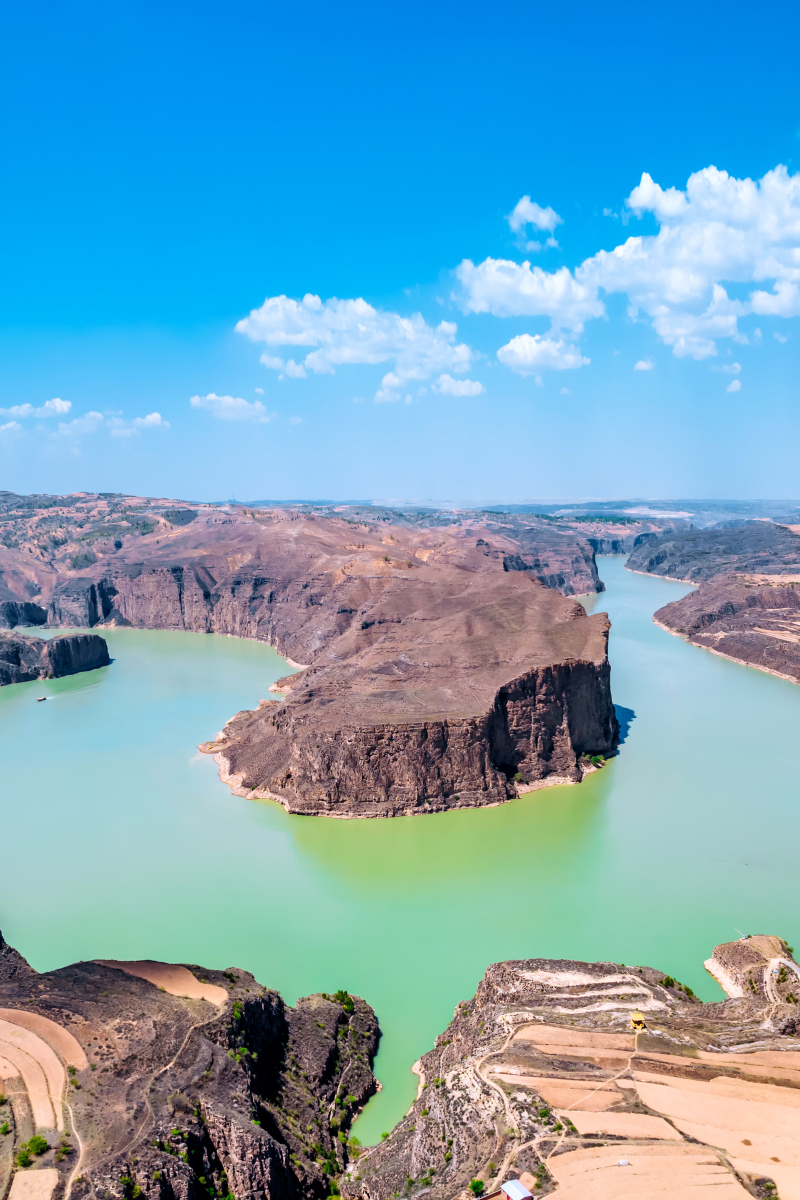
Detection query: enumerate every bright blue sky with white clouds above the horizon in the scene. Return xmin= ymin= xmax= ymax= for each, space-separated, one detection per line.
xmin=0 ymin=0 xmax=800 ymax=503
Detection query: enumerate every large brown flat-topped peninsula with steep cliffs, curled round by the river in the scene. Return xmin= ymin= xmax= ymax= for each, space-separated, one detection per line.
xmin=0 ymin=502 xmax=618 ymax=817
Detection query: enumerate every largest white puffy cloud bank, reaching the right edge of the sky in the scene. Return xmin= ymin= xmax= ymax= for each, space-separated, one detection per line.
xmin=456 ymin=167 xmax=800 ymax=359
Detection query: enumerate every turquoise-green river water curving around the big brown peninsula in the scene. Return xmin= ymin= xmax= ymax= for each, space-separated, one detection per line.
xmin=0 ymin=558 xmax=800 ymax=1142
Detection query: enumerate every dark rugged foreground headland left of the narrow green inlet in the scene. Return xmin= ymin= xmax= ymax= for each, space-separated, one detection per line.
xmin=0 ymin=940 xmax=379 ymax=1200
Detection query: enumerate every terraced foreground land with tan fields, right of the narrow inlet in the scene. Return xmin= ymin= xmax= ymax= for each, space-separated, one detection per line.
xmin=352 ymin=937 xmax=800 ymax=1200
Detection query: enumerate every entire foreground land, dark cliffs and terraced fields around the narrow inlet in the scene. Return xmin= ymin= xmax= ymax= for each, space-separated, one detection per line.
xmin=0 ymin=936 xmax=800 ymax=1200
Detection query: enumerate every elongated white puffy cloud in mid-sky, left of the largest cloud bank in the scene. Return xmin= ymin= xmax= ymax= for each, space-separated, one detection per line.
xmin=236 ymin=295 xmax=473 ymax=403
